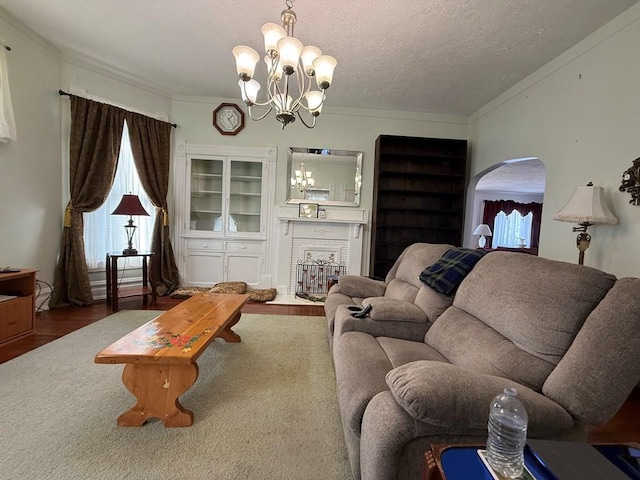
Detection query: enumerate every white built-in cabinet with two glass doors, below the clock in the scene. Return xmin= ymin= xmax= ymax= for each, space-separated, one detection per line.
xmin=175 ymin=141 xmax=276 ymax=288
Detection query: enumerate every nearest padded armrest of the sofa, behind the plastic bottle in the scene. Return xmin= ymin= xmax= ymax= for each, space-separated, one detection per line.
xmin=386 ymin=361 xmax=574 ymax=437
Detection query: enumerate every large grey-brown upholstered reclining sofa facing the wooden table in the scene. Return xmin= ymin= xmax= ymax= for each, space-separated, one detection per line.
xmin=325 ymin=244 xmax=640 ymax=480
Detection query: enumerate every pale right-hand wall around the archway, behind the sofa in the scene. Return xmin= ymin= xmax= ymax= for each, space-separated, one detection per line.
xmin=466 ymin=4 xmax=640 ymax=276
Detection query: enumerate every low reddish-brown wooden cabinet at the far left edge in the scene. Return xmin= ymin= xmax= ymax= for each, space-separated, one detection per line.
xmin=0 ymin=269 xmax=37 ymax=345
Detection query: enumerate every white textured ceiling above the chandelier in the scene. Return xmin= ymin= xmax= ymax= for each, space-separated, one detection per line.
xmin=0 ymin=0 xmax=638 ymax=115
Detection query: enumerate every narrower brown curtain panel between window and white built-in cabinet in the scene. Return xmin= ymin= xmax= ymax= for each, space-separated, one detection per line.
xmin=127 ymin=112 xmax=180 ymax=295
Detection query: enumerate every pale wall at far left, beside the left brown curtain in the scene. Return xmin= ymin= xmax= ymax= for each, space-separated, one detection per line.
xmin=0 ymin=9 xmax=62 ymax=283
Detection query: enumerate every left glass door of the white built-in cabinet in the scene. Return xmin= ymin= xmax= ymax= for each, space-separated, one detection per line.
xmin=189 ymin=158 xmax=224 ymax=232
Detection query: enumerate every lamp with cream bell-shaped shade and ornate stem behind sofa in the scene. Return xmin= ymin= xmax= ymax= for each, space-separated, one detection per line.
xmin=553 ymin=182 xmax=618 ymax=265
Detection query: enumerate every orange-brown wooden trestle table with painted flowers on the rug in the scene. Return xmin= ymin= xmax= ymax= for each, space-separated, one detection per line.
xmin=94 ymin=293 xmax=249 ymax=427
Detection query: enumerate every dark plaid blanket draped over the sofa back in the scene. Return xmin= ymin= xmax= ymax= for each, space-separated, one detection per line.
xmin=420 ymin=248 xmax=487 ymax=296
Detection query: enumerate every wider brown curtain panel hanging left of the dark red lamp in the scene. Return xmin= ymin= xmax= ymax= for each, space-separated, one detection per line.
xmin=49 ymin=95 xmax=126 ymax=308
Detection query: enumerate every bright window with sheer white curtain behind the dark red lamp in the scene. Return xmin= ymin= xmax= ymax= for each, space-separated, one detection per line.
xmin=84 ymin=122 xmax=155 ymax=270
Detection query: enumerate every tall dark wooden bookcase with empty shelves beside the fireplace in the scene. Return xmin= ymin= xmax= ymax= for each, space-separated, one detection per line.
xmin=370 ymin=135 xmax=467 ymax=278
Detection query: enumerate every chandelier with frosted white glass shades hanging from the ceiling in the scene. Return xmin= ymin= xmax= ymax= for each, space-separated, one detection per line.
xmin=233 ymin=0 xmax=337 ymax=129
